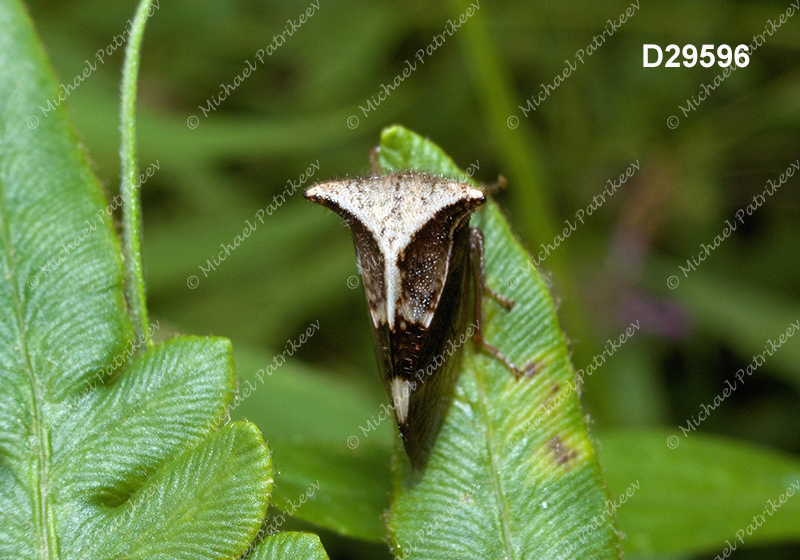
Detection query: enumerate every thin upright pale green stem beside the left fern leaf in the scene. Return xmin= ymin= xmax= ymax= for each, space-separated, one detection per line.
xmin=119 ymin=0 xmax=153 ymax=348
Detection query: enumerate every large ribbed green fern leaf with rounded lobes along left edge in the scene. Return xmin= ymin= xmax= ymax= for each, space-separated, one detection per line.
xmin=0 ymin=0 xmax=272 ymax=559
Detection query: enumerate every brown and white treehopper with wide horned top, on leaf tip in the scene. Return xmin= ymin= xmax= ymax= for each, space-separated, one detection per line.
xmin=304 ymin=172 xmax=494 ymax=469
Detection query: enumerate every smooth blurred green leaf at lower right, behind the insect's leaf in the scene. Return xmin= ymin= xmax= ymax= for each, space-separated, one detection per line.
xmin=598 ymin=431 xmax=800 ymax=554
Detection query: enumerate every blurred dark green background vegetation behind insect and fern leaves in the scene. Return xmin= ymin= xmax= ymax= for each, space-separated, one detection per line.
xmin=25 ymin=0 xmax=800 ymax=559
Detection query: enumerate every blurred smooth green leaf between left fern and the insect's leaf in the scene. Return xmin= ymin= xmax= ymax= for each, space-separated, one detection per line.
xmin=231 ymin=346 xmax=391 ymax=541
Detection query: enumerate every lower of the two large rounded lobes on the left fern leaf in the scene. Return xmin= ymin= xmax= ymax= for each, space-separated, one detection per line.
xmin=77 ymin=422 xmax=272 ymax=560
